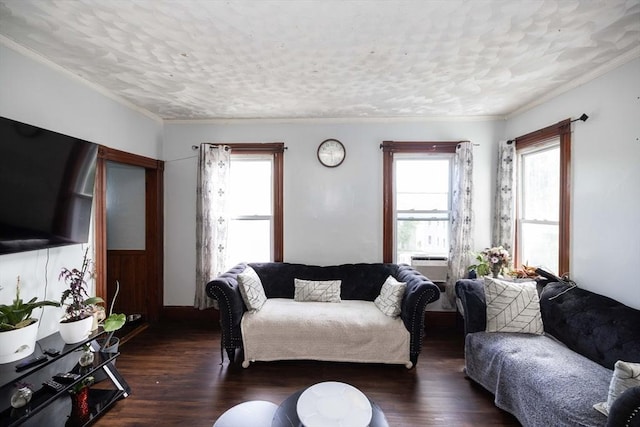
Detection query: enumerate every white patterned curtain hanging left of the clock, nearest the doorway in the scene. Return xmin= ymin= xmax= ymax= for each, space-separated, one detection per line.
xmin=194 ymin=144 xmax=231 ymax=310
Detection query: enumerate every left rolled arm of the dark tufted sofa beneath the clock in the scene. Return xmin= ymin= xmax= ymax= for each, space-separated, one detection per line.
xmin=205 ymin=263 xmax=247 ymax=350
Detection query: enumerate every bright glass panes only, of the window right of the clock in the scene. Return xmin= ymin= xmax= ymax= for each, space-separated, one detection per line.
xmin=394 ymin=157 xmax=451 ymax=264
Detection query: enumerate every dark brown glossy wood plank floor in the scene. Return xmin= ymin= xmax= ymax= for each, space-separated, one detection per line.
xmin=96 ymin=323 xmax=520 ymax=427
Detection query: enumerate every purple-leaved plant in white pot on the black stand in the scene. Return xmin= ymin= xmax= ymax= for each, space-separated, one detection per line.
xmin=58 ymin=248 xmax=104 ymax=344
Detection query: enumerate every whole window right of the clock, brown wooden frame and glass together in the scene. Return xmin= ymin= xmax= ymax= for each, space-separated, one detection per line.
xmin=382 ymin=141 xmax=458 ymax=264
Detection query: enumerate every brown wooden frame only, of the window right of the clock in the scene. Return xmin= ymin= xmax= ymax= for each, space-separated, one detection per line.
xmin=380 ymin=141 xmax=464 ymax=263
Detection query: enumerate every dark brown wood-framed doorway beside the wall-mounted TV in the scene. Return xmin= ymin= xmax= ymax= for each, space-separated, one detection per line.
xmin=95 ymin=146 xmax=164 ymax=322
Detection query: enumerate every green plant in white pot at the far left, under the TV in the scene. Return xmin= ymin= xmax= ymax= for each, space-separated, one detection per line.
xmin=0 ymin=276 xmax=60 ymax=363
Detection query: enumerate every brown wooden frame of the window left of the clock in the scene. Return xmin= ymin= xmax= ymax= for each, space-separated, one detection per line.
xmin=224 ymin=142 xmax=285 ymax=262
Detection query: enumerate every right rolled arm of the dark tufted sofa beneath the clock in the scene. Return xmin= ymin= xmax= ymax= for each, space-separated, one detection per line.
xmin=396 ymin=264 xmax=440 ymax=365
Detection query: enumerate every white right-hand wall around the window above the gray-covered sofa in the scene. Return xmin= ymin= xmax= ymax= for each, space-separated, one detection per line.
xmin=506 ymin=59 xmax=640 ymax=309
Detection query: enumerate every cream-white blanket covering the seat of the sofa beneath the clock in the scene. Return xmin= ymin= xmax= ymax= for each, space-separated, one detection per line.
xmin=241 ymin=298 xmax=411 ymax=367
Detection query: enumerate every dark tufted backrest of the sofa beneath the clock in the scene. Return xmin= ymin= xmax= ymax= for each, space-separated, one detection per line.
xmin=249 ymin=262 xmax=398 ymax=301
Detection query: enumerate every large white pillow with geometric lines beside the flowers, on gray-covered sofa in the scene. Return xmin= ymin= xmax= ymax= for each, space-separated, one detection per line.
xmin=484 ymin=277 xmax=544 ymax=335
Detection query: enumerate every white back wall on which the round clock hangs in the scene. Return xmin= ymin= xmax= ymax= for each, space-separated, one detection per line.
xmin=163 ymin=120 xmax=504 ymax=305
